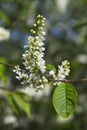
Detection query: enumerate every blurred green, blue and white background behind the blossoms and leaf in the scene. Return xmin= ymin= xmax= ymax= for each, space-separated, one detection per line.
xmin=0 ymin=0 xmax=87 ymax=130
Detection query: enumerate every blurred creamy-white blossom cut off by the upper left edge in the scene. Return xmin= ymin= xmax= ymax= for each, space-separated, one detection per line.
xmin=0 ymin=27 xmax=10 ymax=41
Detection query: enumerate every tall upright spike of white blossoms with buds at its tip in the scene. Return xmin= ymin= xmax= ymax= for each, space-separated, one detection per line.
xmin=13 ymin=15 xmax=48 ymax=91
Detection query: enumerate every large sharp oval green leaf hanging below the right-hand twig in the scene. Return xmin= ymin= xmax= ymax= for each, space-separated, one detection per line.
xmin=52 ymin=83 xmax=77 ymax=118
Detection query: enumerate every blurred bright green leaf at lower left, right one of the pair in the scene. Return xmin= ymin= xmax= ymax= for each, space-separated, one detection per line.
xmin=13 ymin=92 xmax=30 ymax=116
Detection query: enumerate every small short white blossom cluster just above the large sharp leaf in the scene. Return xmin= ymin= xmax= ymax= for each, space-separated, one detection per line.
xmin=49 ymin=60 xmax=70 ymax=85
